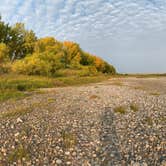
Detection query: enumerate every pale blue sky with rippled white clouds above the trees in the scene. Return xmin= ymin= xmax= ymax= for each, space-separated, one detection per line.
xmin=0 ymin=0 xmax=166 ymax=73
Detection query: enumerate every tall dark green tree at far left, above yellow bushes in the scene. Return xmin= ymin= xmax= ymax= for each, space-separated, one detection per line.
xmin=0 ymin=16 xmax=37 ymax=61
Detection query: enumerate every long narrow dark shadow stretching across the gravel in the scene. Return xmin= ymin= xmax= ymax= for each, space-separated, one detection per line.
xmin=100 ymin=107 xmax=122 ymax=166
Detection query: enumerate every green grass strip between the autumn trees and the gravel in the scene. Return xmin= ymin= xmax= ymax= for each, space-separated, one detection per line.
xmin=0 ymin=74 xmax=110 ymax=101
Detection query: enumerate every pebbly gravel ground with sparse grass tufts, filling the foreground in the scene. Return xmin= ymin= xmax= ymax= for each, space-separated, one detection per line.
xmin=0 ymin=77 xmax=166 ymax=166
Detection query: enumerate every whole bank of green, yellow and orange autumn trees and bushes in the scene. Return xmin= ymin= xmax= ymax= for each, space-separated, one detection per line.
xmin=0 ymin=18 xmax=116 ymax=77
